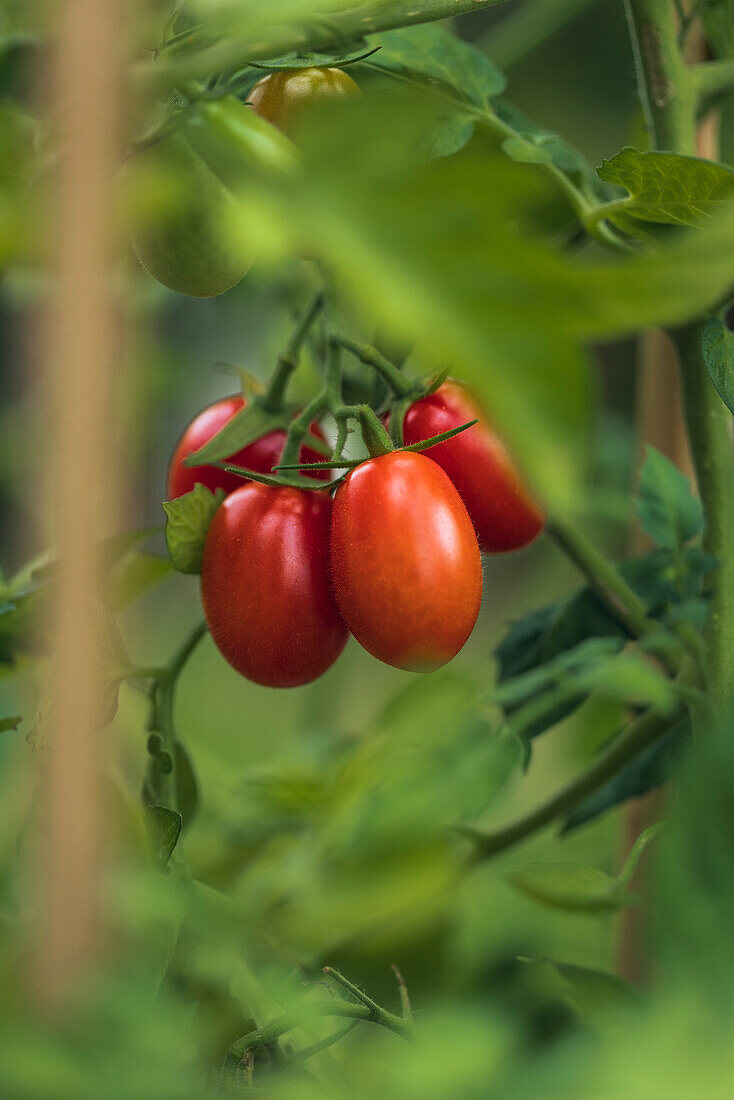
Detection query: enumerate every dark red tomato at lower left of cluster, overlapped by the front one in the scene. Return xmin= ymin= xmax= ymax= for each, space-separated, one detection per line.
xmin=201 ymin=482 xmax=348 ymax=688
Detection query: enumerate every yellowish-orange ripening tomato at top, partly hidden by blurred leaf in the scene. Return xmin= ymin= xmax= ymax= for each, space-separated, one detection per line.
xmin=248 ymin=68 xmax=359 ymax=133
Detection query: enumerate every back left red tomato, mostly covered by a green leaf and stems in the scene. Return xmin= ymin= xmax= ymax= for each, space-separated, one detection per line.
xmin=167 ymin=396 xmax=329 ymax=501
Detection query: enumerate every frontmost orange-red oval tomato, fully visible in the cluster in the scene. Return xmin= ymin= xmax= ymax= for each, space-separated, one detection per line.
xmin=331 ymin=451 xmax=482 ymax=672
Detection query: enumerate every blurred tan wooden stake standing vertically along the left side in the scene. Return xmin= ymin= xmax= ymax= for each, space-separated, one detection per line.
xmin=37 ymin=0 xmax=121 ymax=1009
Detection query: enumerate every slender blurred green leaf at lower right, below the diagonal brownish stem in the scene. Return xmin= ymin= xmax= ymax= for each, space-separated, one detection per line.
xmin=507 ymin=864 xmax=636 ymax=915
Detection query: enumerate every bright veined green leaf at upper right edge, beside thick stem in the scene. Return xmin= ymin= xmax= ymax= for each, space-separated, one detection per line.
xmin=598 ymin=146 xmax=734 ymax=226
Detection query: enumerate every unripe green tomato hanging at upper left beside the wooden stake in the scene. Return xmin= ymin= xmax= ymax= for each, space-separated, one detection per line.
xmin=129 ymin=133 xmax=254 ymax=298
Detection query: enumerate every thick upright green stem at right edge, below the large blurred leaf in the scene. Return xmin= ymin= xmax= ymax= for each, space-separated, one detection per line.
xmin=671 ymin=322 xmax=734 ymax=705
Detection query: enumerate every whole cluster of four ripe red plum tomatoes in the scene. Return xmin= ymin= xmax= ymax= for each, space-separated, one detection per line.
xmin=168 ymin=384 xmax=543 ymax=688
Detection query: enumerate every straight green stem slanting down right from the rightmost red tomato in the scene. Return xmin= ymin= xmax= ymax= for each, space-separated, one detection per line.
xmin=547 ymin=518 xmax=679 ymax=673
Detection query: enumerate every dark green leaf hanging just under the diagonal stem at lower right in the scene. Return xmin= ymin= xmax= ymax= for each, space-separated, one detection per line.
xmin=562 ymin=719 xmax=691 ymax=833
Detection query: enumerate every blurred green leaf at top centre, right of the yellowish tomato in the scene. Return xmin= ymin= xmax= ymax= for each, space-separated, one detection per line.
xmin=366 ymin=23 xmax=506 ymax=110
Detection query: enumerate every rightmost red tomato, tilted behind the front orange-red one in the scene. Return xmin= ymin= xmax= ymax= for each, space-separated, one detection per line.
xmin=403 ymin=383 xmax=545 ymax=553
